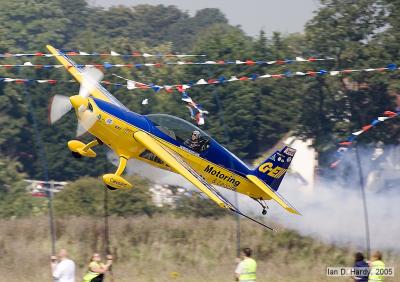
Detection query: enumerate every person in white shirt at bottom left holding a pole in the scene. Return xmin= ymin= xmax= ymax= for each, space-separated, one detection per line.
xmin=50 ymin=249 xmax=75 ymax=282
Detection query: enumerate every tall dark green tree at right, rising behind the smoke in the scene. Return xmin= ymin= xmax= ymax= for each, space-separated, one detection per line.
xmin=297 ymin=0 xmax=392 ymax=165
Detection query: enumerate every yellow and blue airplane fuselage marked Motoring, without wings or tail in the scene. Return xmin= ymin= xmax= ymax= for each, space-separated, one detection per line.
xmin=82 ymin=98 xmax=269 ymax=199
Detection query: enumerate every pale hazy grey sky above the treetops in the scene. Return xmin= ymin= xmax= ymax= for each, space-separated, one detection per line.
xmin=93 ymin=0 xmax=319 ymax=35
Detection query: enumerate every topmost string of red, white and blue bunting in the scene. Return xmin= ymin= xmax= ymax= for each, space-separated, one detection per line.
xmin=0 ymin=57 xmax=332 ymax=69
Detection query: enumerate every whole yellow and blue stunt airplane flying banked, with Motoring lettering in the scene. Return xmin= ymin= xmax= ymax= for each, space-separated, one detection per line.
xmin=47 ymin=45 xmax=300 ymax=228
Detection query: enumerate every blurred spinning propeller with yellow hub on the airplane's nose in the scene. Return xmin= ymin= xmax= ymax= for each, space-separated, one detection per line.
xmin=49 ymin=67 xmax=103 ymax=136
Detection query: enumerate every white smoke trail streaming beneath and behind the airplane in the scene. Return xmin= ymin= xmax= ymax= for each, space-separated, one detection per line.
xmin=107 ymin=145 xmax=400 ymax=250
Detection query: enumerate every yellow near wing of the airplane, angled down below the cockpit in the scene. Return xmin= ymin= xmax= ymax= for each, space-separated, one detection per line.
xmin=133 ymin=131 xmax=273 ymax=230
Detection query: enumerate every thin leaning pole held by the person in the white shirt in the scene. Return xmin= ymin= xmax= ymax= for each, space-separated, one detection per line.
xmin=24 ymin=84 xmax=56 ymax=255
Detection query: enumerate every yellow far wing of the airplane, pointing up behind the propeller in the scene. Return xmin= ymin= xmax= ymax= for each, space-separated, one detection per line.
xmin=46 ymin=45 xmax=128 ymax=110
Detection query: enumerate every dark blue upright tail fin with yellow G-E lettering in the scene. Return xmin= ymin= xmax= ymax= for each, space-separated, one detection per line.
xmin=253 ymin=146 xmax=296 ymax=191
